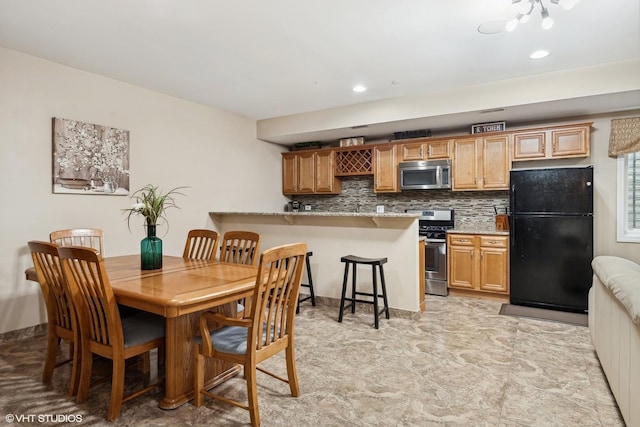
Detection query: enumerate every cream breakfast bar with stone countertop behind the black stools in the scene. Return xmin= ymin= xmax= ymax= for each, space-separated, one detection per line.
xmin=209 ymin=211 xmax=424 ymax=318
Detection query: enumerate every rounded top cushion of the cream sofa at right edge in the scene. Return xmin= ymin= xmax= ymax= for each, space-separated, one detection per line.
xmin=591 ymin=256 xmax=640 ymax=326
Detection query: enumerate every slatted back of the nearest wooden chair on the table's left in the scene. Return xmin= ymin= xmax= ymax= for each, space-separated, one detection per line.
xmin=58 ymin=246 xmax=124 ymax=346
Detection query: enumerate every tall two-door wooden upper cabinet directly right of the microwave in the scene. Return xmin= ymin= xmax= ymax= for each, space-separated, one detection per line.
xmin=452 ymin=134 xmax=510 ymax=191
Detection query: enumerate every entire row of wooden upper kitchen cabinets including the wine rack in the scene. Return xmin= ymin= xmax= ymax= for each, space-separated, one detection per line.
xmin=282 ymin=123 xmax=592 ymax=195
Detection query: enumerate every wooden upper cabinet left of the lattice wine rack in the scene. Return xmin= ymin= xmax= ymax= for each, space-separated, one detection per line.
xmin=282 ymin=150 xmax=342 ymax=195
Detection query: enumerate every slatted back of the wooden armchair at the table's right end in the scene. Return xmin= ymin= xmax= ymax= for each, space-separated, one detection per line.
xmin=249 ymin=243 xmax=307 ymax=350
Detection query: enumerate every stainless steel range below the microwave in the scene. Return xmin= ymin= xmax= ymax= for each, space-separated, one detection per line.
xmin=407 ymin=209 xmax=454 ymax=296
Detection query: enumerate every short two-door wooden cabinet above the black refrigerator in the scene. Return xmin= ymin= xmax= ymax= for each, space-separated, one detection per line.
xmin=513 ymin=123 xmax=591 ymax=161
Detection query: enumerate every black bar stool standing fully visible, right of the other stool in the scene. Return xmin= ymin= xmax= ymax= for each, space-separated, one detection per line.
xmin=338 ymin=255 xmax=389 ymax=329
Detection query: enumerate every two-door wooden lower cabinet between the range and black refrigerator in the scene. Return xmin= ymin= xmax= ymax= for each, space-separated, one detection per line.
xmin=447 ymin=233 xmax=509 ymax=295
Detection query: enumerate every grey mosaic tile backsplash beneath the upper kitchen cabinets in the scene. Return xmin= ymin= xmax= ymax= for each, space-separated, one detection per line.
xmin=291 ymin=176 xmax=509 ymax=226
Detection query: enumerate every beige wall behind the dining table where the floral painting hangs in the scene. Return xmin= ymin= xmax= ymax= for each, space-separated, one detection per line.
xmin=0 ymin=48 xmax=286 ymax=333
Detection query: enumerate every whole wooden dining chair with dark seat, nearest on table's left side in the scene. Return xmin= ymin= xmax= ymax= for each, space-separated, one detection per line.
xmin=58 ymin=246 xmax=165 ymax=421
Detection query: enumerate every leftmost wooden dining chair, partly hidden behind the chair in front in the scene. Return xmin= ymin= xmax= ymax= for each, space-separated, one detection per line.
xmin=28 ymin=240 xmax=80 ymax=396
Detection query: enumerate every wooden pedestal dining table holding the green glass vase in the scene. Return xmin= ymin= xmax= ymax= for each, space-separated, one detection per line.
xmin=26 ymin=255 xmax=258 ymax=409
